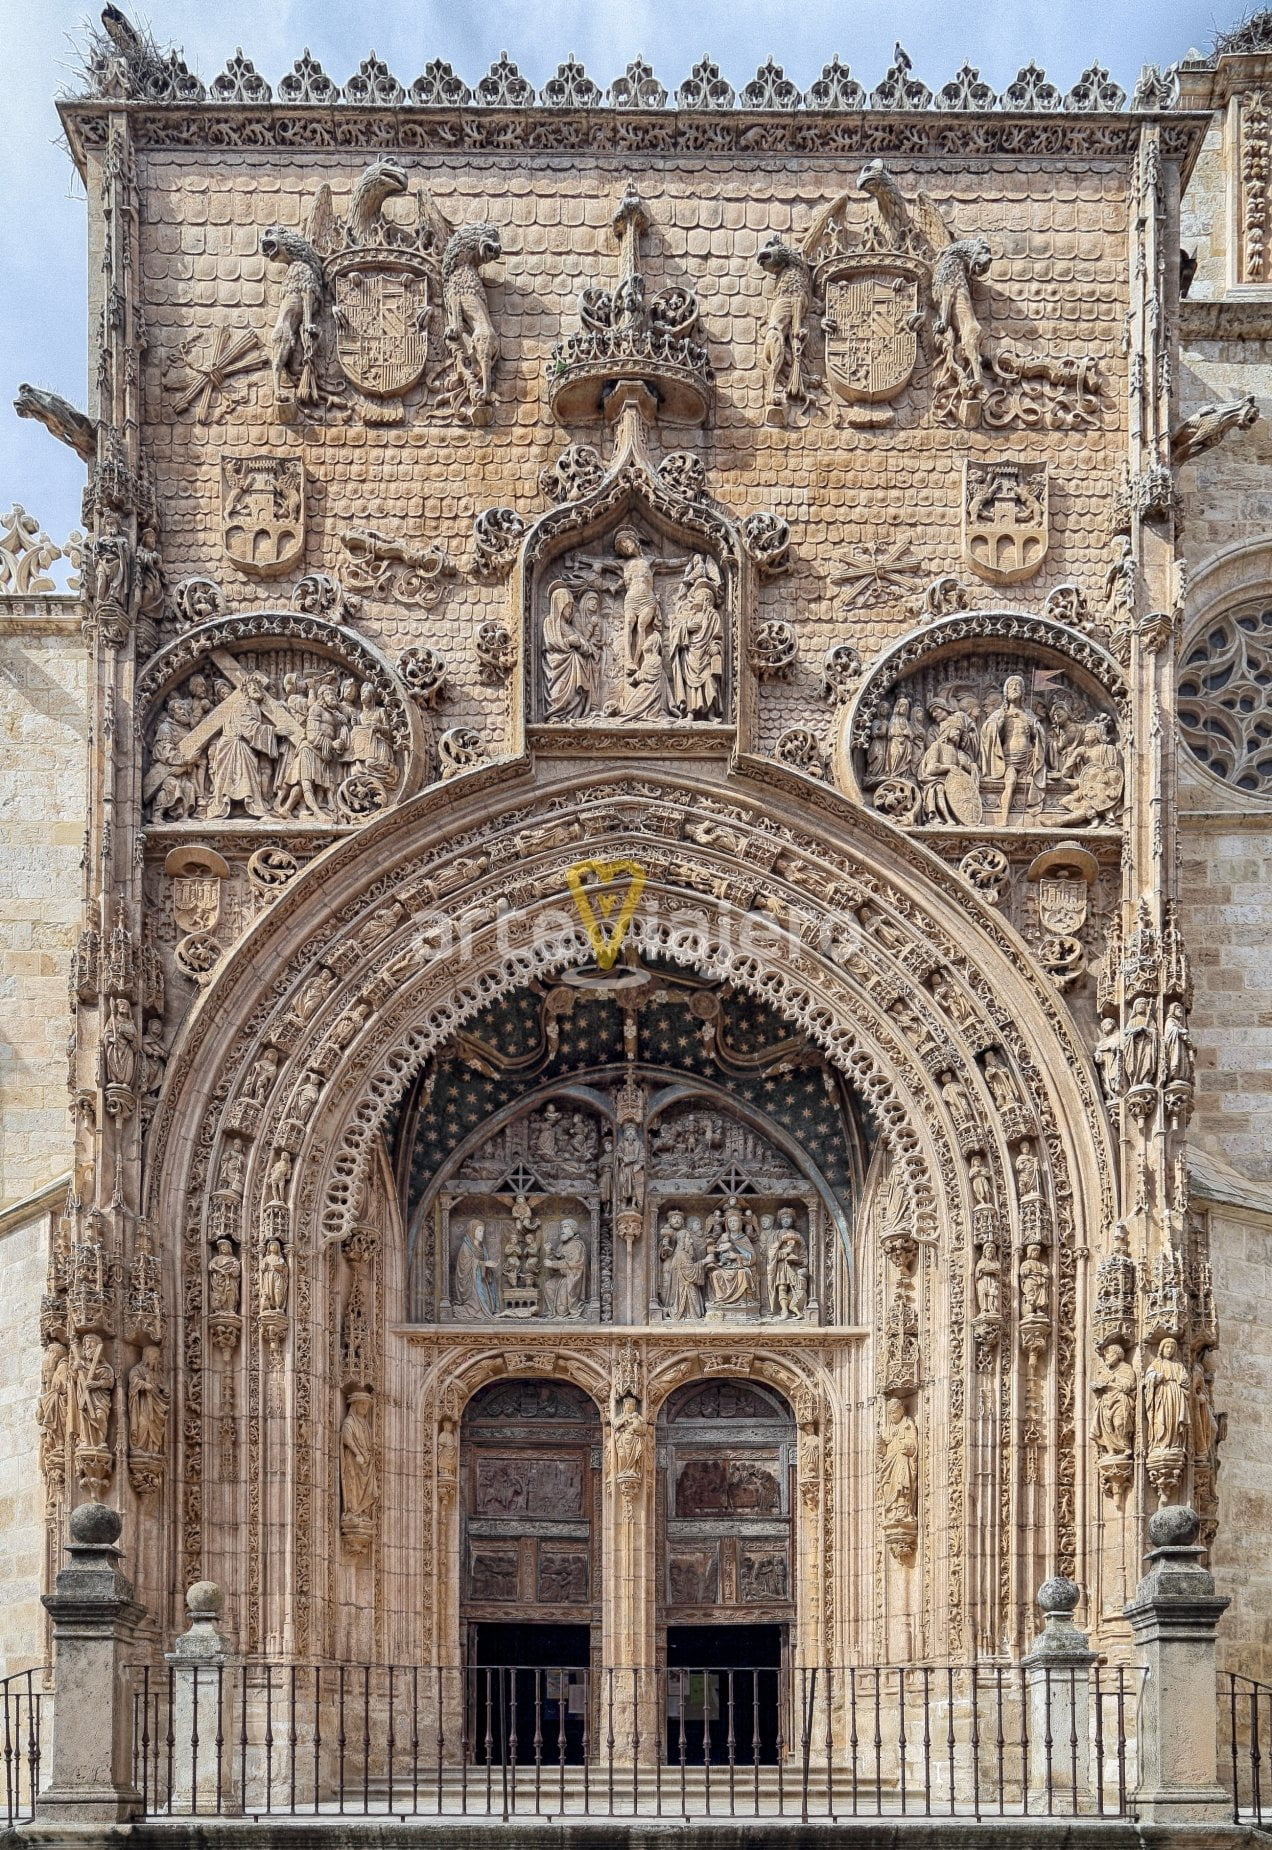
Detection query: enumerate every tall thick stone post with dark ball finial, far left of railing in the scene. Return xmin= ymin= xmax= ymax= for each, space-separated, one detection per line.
xmin=35 ymin=1502 xmax=144 ymax=1826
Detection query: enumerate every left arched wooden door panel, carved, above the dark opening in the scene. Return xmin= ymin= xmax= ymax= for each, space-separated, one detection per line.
xmin=460 ymin=1382 xmax=601 ymax=1624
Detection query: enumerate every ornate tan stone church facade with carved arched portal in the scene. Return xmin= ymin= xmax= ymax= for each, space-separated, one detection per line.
xmin=0 ymin=7 xmax=1272 ymax=1783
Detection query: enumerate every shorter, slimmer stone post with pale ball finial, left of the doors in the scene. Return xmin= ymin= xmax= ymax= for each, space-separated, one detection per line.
xmin=168 ymin=1580 xmax=242 ymax=1817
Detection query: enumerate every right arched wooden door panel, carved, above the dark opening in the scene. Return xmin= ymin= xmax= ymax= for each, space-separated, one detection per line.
xmin=658 ymin=1380 xmax=795 ymax=1626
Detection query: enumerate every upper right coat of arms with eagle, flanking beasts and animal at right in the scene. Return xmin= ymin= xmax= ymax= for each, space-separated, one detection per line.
xmin=758 ymin=159 xmax=1100 ymax=432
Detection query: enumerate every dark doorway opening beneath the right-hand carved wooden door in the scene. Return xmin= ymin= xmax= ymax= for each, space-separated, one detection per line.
xmin=666 ymin=1624 xmax=786 ymax=1767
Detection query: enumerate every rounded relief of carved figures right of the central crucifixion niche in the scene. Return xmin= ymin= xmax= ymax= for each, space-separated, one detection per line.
xmin=856 ymin=653 xmax=1124 ymax=829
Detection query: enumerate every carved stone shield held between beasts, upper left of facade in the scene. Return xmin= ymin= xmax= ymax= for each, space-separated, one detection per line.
xmin=327 ymin=248 xmax=434 ymax=398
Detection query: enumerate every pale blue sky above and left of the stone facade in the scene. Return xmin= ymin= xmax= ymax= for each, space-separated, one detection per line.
xmin=0 ymin=0 xmax=1239 ymax=555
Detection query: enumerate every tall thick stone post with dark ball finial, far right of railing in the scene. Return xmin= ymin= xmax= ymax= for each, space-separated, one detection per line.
xmin=1126 ymin=1504 xmax=1231 ymax=1824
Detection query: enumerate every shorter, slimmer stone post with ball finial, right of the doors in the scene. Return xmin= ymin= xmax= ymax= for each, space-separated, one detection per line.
xmin=1022 ymin=1574 xmax=1095 ymax=1817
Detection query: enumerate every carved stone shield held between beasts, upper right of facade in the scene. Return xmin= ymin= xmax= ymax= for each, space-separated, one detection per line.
xmin=821 ymin=252 xmax=921 ymax=405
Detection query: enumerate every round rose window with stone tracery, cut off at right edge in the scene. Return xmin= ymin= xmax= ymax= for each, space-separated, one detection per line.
xmin=1178 ymin=605 xmax=1272 ymax=797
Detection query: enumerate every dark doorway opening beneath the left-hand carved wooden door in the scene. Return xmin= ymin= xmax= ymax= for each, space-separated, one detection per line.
xmin=468 ymin=1622 xmax=592 ymax=1767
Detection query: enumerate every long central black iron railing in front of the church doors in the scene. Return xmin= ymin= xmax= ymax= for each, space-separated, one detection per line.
xmin=131 ymin=1663 xmax=1139 ymax=1820
